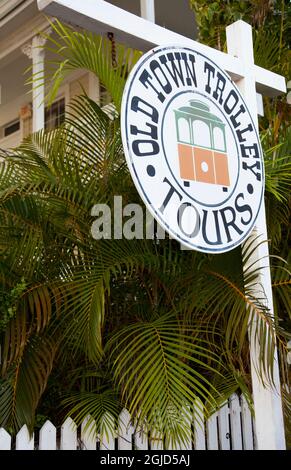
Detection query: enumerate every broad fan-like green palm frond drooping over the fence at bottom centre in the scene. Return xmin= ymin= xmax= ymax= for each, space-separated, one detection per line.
xmin=108 ymin=315 xmax=235 ymax=434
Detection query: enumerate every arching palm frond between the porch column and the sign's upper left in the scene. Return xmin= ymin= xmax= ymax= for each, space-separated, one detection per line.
xmin=28 ymin=20 xmax=141 ymax=111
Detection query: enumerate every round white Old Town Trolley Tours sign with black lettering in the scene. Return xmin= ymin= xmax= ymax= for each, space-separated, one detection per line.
xmin=121 ymin=46 xmax=264 ymax=253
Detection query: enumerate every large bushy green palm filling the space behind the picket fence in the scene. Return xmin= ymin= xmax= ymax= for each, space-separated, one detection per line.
xmin=0 ymin=22 xmax=291 ymax=442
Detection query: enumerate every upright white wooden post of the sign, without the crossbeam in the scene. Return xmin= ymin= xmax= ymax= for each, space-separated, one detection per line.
xmin=226 ymin=20 xmax=286 ymax=450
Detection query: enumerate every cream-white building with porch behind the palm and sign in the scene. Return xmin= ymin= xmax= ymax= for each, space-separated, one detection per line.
xmin=0 ymin=0 xmax=196 ymax=149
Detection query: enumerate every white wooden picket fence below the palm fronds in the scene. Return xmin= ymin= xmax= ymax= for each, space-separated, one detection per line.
xmin=0 ymin=394 xmax=256 ymax=450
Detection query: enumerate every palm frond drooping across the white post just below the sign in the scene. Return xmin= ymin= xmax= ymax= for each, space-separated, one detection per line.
xmin=210 ymin=237 xmax=276 ymax=381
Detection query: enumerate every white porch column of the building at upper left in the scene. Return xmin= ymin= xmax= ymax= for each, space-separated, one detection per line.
xmin=22 ymin=28 xmax=51 ymax=132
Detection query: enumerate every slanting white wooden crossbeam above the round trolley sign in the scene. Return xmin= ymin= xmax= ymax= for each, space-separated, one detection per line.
xmin=38 ymin=0 xmax=286 ymax=96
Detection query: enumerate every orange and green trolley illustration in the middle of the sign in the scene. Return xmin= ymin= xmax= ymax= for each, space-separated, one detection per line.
xmin=174 ymin=100 xmax=230 ymax=191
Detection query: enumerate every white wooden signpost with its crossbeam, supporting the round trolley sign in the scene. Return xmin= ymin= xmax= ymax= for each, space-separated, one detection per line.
xmin=38 ymin=0 xmax=286 ymax=450
